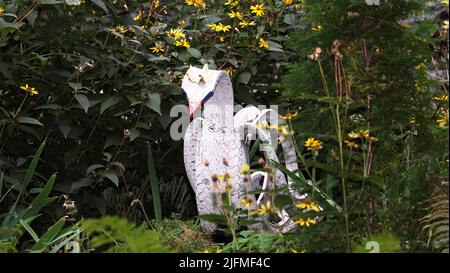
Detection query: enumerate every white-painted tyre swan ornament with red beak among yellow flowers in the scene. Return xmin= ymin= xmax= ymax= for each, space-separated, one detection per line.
xmin=181 ymin=65 xmax=305 ymax=233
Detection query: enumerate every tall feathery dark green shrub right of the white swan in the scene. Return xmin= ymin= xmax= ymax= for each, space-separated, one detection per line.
xmin=283 ymin=0 xmax=448 ymax=250
